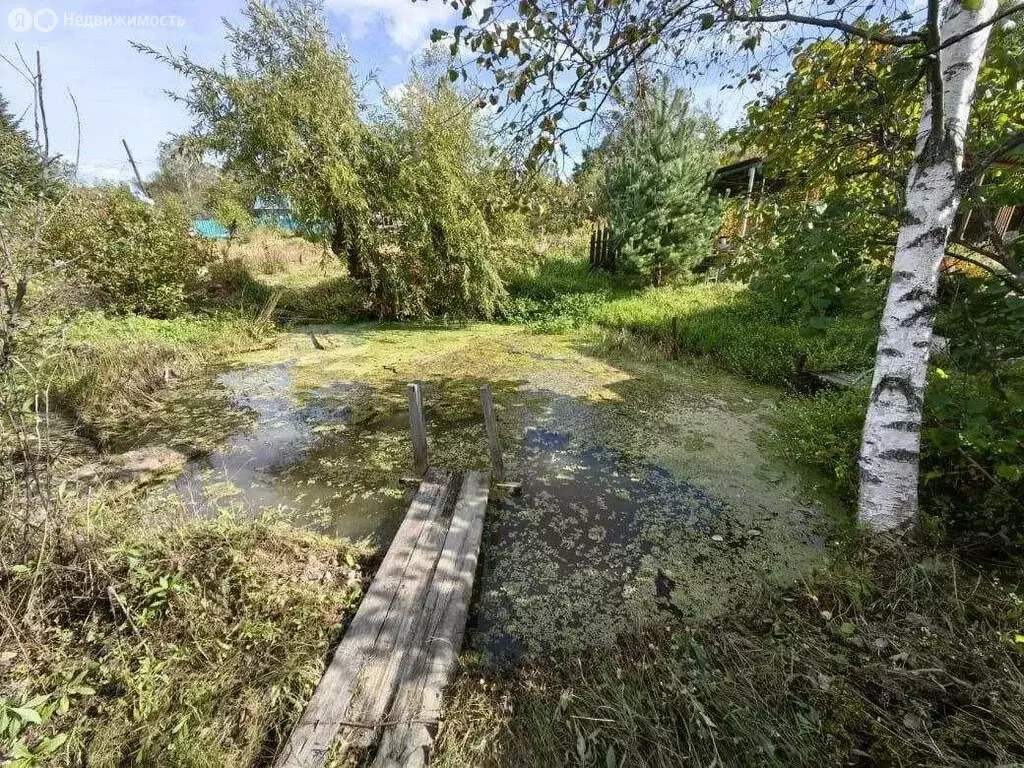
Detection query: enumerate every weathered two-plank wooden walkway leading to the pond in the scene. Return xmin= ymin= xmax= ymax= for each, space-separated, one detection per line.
xmin=275 ymin=469 xmax=490 ymax=768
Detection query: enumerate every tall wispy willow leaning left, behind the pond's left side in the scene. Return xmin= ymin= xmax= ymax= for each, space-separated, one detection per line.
xmin=135 ymin=0 xmax=367 ymax=276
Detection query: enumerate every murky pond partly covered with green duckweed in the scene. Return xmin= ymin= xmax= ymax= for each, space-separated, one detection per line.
xmin=119 ymin=325 xmax=829 ymax=658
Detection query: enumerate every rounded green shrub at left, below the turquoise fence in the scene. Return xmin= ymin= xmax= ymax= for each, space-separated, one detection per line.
xmin=46 ymin=187 xmax=211 ymax=317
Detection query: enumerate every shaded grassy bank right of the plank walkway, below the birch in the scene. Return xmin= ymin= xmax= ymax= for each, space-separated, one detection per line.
xmin=434 ymin=543 xmax=1024 ymax=766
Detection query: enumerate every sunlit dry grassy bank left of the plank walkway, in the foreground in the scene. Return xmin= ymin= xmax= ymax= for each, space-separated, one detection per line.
xmin=0 ymin=490 xmax=369 ymax=766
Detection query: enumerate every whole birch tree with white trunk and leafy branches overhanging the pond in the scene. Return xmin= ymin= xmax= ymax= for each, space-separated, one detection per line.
xmin=436 ymin=0 xmax=1024 ymax=529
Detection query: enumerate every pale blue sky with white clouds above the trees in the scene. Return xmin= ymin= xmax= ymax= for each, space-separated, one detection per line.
xmin=0 ymin=0 xmax=745 ymax=181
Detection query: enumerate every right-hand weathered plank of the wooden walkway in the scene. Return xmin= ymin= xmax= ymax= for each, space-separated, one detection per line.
xmin=374 ymin=472 xmax=489 ymax=768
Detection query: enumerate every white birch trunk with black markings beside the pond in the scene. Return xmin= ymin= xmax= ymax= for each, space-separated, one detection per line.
xmin=858 ymin=0 xmax=997 ymax=530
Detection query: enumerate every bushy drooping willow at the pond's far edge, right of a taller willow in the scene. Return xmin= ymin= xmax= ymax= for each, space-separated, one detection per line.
xmin=362 ymin=73 xmax=516 ymax=318
